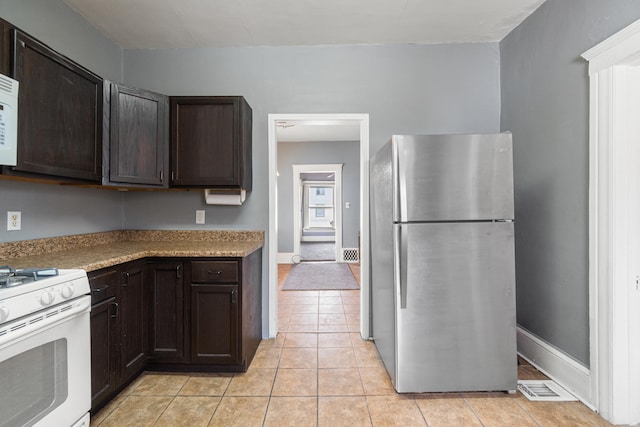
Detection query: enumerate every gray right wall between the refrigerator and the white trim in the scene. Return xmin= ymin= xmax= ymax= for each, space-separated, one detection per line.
xmin=500 ymin=0 xmax=640 ymax=366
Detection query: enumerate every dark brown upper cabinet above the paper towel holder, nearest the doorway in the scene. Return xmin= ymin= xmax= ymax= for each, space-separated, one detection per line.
xmin=170 ymin=96 xmax=252 ymax=191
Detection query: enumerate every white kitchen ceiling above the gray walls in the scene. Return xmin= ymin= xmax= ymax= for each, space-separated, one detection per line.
xmin=64 ymin=0 xmax=544 ymax=49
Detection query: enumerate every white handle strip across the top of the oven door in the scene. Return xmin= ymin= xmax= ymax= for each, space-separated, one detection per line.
xmin=0 ymin=295 xmax=91 ymax=349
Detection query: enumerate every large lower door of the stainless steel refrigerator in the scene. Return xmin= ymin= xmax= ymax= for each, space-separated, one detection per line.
xmin=391 ymin=222 xmax=517 ymax=393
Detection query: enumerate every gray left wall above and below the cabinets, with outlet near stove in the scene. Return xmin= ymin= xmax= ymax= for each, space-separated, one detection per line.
xmin=0 ymin=0 xmax=122 ymax=242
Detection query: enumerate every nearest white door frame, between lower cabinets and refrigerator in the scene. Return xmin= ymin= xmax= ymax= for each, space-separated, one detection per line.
xmin=268 ymin=114 xmax=371 ymax=339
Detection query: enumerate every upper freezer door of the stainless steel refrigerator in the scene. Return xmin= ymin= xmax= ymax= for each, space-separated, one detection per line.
xmin=392 ymin=133 xmax=513 ymax=222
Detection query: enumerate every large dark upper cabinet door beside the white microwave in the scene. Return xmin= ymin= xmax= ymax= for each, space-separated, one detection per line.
xmin=10 ymin=30 xmax=103 ymax=182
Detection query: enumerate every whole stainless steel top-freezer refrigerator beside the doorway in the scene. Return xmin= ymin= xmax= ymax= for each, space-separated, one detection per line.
xmin=370 ymin=133 xmax=517 ymax=393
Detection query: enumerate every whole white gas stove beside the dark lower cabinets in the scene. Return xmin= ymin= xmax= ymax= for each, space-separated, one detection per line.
xmin=0 ymin=267 xmax=91 ymax=427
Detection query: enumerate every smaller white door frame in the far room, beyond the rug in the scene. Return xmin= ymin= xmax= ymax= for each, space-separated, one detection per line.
xmin=292 ymin=163 xmax=343 ymax=262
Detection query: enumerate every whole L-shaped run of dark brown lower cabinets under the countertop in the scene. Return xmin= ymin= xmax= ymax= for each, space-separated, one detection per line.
xmin=89 ymin=249 xmax=262 ymax=413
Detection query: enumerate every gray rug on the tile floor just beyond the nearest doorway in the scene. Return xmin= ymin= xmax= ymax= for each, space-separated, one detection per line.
xmin=282 ymin=262 xmax=359 ymax=291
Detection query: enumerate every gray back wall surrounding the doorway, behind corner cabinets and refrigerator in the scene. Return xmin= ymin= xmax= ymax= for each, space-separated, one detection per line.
xmin=124 ymin=43 xmax=500 ymax=334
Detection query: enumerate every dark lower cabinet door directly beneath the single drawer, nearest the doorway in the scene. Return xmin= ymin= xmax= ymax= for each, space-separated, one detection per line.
xmin=191 ymin=284 xmax=239 ymax=365
